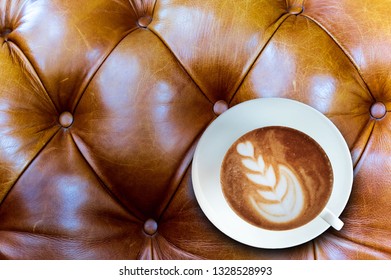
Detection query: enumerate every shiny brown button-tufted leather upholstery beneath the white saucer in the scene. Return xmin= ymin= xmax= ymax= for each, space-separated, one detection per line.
xmin=0 ymin=0 xmax=391 ymax=259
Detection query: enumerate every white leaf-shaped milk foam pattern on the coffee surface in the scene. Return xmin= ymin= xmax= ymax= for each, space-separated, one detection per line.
xmin=236 ymin=141 xmax=304 ymax=223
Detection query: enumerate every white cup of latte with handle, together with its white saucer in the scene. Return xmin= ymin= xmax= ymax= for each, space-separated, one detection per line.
xmin=192 ymin=98 xmax=353 ymax=249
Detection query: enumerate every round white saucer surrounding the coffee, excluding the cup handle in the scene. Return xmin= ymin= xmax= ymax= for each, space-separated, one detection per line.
xmin=192 ymin=98 xmax=353 ymax=249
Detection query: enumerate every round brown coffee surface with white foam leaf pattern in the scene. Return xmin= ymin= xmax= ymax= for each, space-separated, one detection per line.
xmin=220 ymin=126 xmax=333 ymax=230
